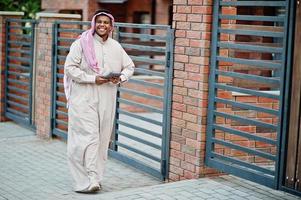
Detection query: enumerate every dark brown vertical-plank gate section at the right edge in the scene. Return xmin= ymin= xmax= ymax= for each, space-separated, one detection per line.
xmin=282 ymin=1 xmax=301 ymax=196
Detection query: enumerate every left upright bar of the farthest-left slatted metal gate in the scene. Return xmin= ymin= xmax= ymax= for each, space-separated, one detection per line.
xmin=4 ymin=19 xmax=10 ymax=119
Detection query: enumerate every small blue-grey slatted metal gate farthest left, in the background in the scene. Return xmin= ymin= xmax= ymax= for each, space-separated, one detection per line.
xmin=5 ymin=19 xmax=36 ymax=126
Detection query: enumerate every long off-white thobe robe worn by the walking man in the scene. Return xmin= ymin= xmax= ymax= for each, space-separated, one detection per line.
xmin=64 ymin=34 xmax=134 ymax=191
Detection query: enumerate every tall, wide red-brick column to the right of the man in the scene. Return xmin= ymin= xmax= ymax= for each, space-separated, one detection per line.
xmin=169 ymin=0 xmax=217 ymax=181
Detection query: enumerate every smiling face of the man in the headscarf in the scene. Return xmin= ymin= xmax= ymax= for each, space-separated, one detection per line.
xmin=95 ymin=15 xmax=112 ymax=39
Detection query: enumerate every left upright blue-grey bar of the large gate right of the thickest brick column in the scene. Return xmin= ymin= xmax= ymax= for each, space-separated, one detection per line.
xmin=205 ymin=1 xmax=220 ymax=165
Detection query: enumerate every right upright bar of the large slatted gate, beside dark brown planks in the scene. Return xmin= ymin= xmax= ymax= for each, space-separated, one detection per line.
xmin=274 ymin=0 xmax=289 ymax=189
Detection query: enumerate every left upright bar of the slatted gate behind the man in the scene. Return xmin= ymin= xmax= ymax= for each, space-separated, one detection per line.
xmin=50 ymin=22 xmax=58 ymax=138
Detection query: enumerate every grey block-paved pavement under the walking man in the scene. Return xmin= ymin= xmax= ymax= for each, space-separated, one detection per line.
xmin=0 ymin=122 xmax=301 ymax=200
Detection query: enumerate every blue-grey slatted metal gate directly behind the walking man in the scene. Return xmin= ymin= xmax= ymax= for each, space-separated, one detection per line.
xmin=52 ymin=21 xmax=174 ymax=179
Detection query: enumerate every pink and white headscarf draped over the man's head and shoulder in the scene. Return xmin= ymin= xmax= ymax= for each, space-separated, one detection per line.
xmin=64 ymin=12 xmax=115 ymax=106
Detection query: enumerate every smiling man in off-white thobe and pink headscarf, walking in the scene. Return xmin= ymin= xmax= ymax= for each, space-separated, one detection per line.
xmin=64 ymin=11 xmax=134 ymax=192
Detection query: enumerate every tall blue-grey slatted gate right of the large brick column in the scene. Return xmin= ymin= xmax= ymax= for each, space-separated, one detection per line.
xmin=206 ymin=0 xmax=289 ymax=187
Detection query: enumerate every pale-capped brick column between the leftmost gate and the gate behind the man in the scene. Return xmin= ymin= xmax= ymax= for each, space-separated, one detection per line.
xmin=34 ymin=13 xmax=81 ymax=138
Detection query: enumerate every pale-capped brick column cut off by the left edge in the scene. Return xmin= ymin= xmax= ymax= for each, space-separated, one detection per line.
xmin=0 ymin=11 xmax=24 ymax=122
